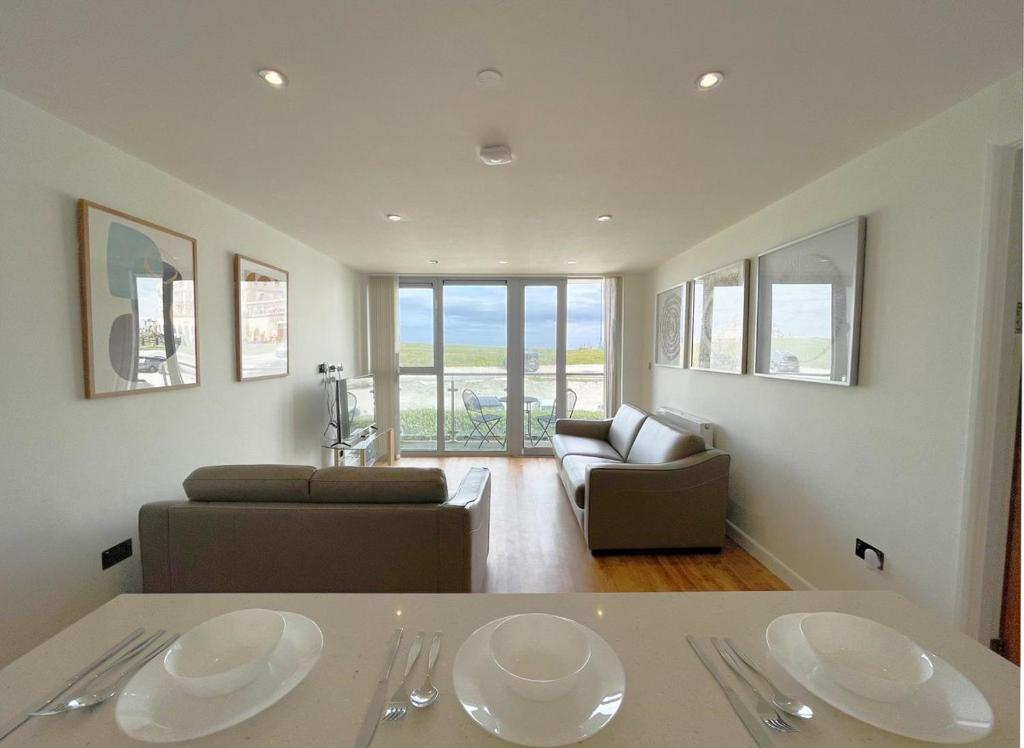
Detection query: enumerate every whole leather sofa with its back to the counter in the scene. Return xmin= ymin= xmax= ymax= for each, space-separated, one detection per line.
xmin=138 ymin=465 xmax=490 ymax=592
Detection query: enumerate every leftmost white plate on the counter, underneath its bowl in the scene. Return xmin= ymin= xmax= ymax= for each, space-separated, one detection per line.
xmin=114 ymin=611 xmax=324 ymax=743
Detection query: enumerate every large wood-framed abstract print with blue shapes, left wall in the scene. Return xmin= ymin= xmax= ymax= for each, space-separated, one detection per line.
xmin=78 ymin=200 xmax=199 ymax=399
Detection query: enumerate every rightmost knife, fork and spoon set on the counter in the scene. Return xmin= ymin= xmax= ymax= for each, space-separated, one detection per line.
xmin=686 ymin=635 xmax=814 ymax=748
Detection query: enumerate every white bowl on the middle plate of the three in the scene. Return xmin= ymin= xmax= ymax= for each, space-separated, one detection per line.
xmin=490 ymin=613 xmax=591 ymax=701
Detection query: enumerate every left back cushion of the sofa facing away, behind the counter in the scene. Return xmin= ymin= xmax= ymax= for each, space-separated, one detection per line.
xmin=181 ymin=465 xmax=316 ymax=501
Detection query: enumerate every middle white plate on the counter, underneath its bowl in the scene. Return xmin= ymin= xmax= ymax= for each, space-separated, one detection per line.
xmin=452 ymin=618 xmax=626 ymax=747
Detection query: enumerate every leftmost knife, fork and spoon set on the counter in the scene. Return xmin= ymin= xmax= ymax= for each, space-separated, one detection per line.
xmin=0 ymin=628 xmax=178 ymax=741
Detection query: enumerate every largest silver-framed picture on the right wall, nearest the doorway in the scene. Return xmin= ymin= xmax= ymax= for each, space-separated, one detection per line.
xmin=754 ymin=217 xmax=866 ymax=386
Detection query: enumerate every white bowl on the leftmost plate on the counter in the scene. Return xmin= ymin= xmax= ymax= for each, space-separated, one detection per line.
xmin=164 ymin=608 xmax=285 ymax=697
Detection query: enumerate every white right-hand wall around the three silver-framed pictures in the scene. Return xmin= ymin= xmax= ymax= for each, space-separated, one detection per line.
xmin=630 ymin=75 xmax=1021 ymax=620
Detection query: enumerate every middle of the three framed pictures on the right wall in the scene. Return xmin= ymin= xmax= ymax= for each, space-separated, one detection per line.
xmin=689 ymin=259 xmax=751 ymax=374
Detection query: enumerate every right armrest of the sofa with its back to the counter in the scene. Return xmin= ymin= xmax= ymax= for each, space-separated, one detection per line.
xmin=437 ymin=467 xmax=490 ymax=592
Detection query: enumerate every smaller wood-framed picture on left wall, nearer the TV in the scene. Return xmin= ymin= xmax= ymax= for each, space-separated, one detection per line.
xmin=234 ymin=254 xmax=289 ymax=382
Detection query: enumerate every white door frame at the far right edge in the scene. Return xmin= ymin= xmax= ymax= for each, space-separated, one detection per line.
xmin=955 ymin=140 xmax=1021 ymax=645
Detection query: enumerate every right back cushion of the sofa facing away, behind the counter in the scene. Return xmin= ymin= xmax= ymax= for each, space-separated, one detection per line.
xmin=309 ymin=467 xmax=447 ymax=504
